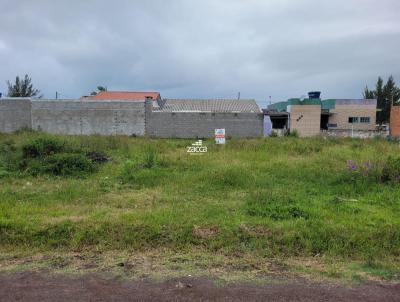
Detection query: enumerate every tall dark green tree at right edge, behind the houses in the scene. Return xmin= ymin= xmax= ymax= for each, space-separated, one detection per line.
xmin=363 ymin=76 xmax=400 ymax=124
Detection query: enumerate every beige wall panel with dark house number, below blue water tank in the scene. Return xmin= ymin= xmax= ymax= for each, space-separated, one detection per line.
xmin=288 ymin=105 xmax=321 ymax=137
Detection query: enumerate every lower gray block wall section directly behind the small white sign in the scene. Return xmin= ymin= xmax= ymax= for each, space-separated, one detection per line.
xmin=146 ymin=111 xmax=264 ymax=138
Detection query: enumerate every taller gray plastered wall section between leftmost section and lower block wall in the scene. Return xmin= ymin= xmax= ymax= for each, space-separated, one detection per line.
xmin=32 ymin=100 xmax=145 ymax=136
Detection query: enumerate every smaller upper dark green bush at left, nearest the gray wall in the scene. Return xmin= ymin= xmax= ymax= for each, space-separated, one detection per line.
xmin=22 ymin=137 xmax=66 ymax=159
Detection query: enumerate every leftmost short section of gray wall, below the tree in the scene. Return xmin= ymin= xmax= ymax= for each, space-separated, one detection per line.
xmin=0 ymin=98 xmax=31 ymax=133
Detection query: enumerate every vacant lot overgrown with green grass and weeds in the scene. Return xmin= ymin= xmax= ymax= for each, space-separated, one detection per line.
xmin=0 ymin=132 xmax=400 ymax=279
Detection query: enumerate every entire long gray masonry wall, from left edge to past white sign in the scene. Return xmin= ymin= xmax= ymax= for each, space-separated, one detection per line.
xmin=0 ymin=98 xmax=263 ymax=138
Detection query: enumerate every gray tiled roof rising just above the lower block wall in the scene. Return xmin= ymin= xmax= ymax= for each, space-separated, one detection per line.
xmin=159 ymin=99 xmax=261 ymax=112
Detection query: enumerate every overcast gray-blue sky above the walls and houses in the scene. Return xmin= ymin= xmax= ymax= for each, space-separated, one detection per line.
xmin=0 ymin=0 xmax=400 ymax=104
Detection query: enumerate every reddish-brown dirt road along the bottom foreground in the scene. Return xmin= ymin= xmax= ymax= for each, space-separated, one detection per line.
xmin=0 ymin=272 xmax=400 ymax=302
